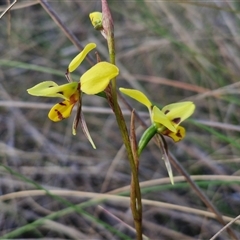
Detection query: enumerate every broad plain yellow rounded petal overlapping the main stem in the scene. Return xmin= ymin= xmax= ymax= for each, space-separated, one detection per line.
xmin=80 ymin=62 xmax=119 ymax=94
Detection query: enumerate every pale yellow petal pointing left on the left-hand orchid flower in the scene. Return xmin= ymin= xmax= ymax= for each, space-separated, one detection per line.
xmin=27 ymin=81 xmax=78 ymax=100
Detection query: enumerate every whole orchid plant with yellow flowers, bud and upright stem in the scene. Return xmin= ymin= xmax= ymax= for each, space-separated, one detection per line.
xmin=27 ymin=0 xmax=195 ymax=239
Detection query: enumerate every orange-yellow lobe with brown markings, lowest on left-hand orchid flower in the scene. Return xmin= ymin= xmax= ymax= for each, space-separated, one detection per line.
xmin=48 ymin=100 xmax=75 ymax=122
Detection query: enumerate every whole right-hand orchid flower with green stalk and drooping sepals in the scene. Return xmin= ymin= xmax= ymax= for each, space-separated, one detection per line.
xmin=120 ymin=88 xmax=195 ymax=184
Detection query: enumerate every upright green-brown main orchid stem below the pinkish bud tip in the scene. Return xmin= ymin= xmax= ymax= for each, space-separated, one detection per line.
xmin=107 ymin=13 xmax=142 ymax=240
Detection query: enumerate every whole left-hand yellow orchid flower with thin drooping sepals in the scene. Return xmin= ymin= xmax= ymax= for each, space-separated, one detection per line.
xmin=27 ymin=43 xmax=119 ymax=148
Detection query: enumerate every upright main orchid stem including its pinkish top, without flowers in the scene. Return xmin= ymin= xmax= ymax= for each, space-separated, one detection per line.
xmin=101 ymin=0 xmax=142 ymax=240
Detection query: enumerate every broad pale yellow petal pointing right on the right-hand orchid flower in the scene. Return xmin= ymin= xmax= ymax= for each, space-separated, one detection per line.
xmin=162 ymin=102 xmax=195 ymax=126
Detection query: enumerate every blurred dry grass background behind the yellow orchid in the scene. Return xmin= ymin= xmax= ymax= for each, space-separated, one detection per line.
xmin=0 ymin=0 xmax=240 ymax=239
